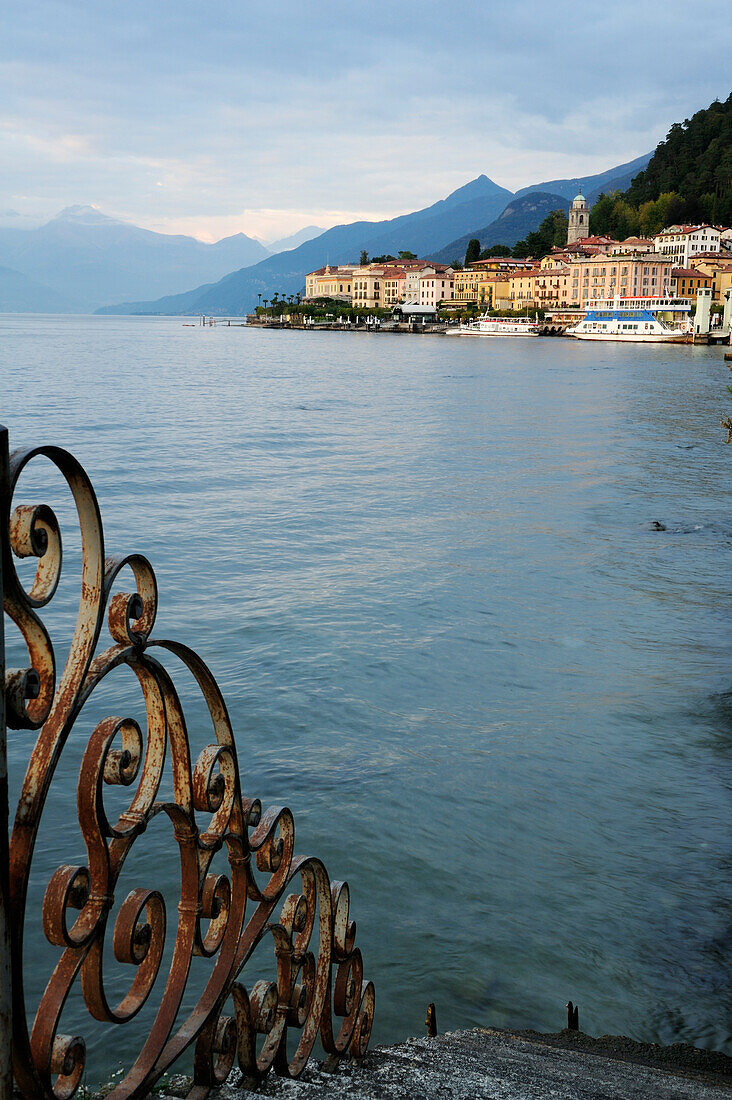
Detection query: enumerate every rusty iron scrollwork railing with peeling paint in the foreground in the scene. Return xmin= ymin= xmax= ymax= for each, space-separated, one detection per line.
xmin=0 ymin=429 xmax=374 ymax=1100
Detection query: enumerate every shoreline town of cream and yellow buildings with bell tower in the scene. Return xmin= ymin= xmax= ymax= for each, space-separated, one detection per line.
xmin=250 ymin=194 xmax=732 ymax=328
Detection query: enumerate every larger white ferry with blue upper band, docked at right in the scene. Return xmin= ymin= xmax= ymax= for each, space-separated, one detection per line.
xmin=567 ymin=295 xmax=693 ymax=343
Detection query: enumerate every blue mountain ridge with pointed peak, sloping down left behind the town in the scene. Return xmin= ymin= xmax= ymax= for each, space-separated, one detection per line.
xmin=94 ymin=176 xmax=512 ymax=316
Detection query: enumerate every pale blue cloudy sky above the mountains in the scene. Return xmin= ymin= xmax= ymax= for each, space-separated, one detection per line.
xmin=0 ymin=0 xmax=732 ymax=241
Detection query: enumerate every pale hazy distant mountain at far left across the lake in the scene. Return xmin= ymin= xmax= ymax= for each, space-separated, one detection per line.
xmin=0 ymin=206 xmax=267 ymax=311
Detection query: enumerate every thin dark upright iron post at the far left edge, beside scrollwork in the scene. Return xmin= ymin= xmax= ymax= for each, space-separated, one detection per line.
xmin=0 ymin=425 xmax=13 ymax=1100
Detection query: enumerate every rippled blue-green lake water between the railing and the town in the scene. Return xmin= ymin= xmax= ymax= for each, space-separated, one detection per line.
xmin=0 ymin=316 xmax=732 ymax=1080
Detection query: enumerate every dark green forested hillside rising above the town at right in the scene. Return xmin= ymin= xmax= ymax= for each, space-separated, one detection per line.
xmin=590 ymin=95 xmax=732 ymax=240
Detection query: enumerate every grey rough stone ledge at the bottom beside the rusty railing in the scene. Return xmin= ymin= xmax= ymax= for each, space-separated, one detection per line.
xmin=143 ymin=1027 xmax=732 ymax=1100
